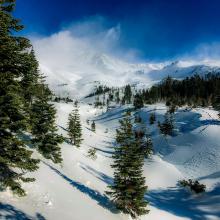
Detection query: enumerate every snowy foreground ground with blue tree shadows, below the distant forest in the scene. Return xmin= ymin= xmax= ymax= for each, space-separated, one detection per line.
xmin=0 ymin=101 xmax=220 ymax=220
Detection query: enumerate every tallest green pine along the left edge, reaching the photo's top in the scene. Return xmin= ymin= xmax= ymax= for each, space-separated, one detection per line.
xmin=0 ymin=0 xmax=39 ymax=195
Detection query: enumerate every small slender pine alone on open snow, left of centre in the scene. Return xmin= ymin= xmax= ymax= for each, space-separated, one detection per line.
xmin=68 ymin=103 xmax=82 ymax=147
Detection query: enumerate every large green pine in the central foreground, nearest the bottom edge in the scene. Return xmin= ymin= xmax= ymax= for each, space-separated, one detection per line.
xmin=107 ymin=113 xmax=148 ymax=218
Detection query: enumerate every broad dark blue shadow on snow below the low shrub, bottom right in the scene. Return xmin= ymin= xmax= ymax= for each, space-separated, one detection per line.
xmin=145 ymin=185 xmax=220 ymax=220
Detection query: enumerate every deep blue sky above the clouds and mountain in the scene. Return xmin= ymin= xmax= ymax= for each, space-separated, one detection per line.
xmin=15 ymin=0 xmax=220 ymax=60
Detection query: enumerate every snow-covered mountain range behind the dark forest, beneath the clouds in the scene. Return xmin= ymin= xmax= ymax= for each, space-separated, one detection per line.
xmin=39 ymin=51 xmax=220 ymax=98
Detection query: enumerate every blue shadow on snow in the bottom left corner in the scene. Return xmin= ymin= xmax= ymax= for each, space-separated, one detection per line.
xmin=0 ymin=202 xmax=46 ymax=220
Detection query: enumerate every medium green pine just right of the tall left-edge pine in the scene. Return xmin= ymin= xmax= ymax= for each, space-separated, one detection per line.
xmin=31 ymin=84 xmax=63 ymax=163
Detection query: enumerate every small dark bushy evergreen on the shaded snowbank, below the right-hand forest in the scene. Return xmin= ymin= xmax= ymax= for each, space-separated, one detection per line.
xmin=158 ymin=112 xmax=174 ymax=136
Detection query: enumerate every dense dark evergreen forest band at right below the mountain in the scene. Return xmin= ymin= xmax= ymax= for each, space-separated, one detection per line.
xmin=139 ymin=73 xmax=220 ymax=107
